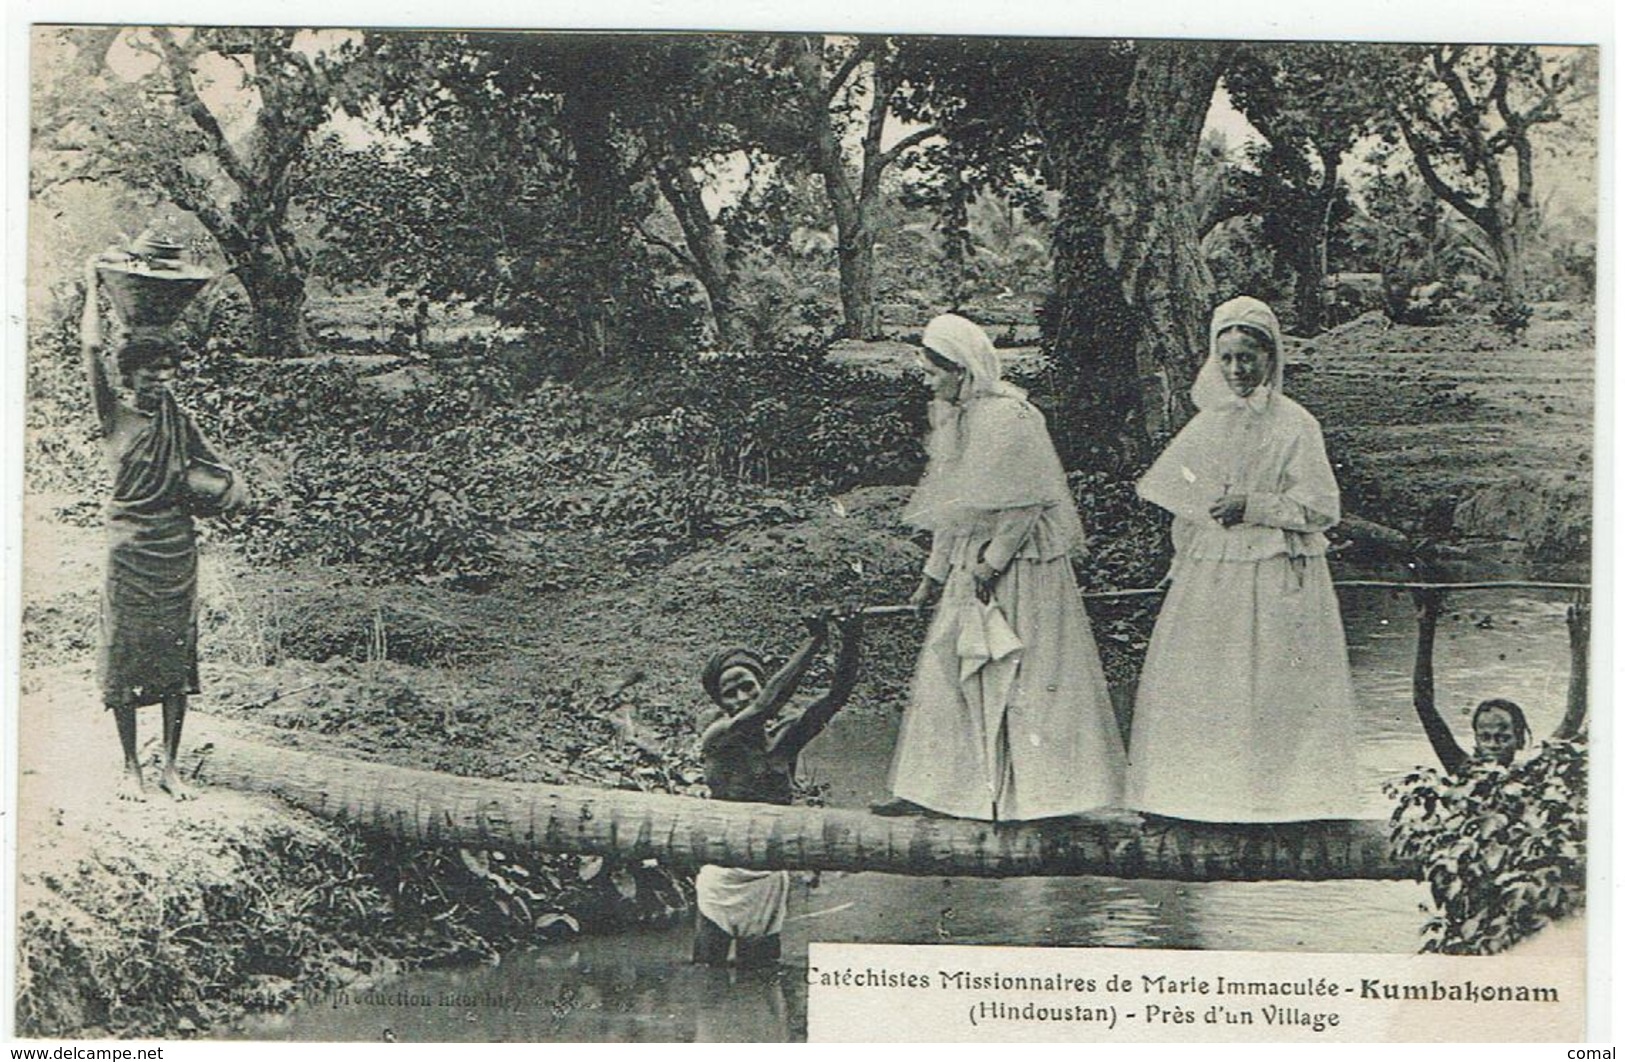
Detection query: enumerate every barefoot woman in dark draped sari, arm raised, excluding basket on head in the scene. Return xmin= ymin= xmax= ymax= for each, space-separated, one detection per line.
xmin=80 ymin=258 xmax=247 ymax=801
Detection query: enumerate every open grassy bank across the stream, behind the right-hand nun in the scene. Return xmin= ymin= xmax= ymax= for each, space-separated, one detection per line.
xmin=1287 ymin=304 xmax=1596 ymax=565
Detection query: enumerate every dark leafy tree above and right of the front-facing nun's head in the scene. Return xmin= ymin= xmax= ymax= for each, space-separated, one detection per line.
xmin=1224 ymin=44 xmax=1388 ymax=335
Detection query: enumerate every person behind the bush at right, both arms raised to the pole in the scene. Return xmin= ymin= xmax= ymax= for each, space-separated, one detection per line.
xmin=1411 ymin=589 xmax=1591 ymax=775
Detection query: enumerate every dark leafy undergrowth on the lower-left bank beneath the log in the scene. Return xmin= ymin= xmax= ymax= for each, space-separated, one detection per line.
xmin=16 ymin=831 xmax=687 ymax=1036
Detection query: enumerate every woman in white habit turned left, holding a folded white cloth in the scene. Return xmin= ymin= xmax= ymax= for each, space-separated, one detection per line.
xmin=876 ymin=313 xmax=1125 ymax=822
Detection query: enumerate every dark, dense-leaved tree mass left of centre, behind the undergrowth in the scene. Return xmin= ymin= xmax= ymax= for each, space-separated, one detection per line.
xmin=319 ymin=34 xmax=692 ymax=364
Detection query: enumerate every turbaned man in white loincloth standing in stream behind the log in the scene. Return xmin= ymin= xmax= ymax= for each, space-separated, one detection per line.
xmin=694 ymin=611 xmax=863 ymax=966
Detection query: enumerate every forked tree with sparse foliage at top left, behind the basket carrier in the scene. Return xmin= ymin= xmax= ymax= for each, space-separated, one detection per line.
xmin=34 ymin=28 xmax=393 ymax=356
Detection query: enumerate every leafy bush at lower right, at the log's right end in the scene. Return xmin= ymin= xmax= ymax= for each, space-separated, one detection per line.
xmin=1388 ymin=740 xmax=1586 ymax=955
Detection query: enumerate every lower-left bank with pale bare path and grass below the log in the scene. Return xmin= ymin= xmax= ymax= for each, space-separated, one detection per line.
xmin=16 ymin=667 xmax=689 ymax=1038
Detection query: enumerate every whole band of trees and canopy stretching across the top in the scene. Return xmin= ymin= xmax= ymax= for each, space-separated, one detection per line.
xmin=34 ymin=28 xmax=1596 ymax=454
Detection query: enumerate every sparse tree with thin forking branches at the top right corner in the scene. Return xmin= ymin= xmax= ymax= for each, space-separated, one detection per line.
xmin=1391 ymin=44 xmax=1597 ymax=304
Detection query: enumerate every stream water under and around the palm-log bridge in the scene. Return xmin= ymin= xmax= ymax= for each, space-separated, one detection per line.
xmin=236 ymin=571 xmax=1568 ymax=1041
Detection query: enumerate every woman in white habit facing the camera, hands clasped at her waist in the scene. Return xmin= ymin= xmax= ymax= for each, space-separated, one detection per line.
xmin=1126 ymin=297 xmax=1359 ymax=822
